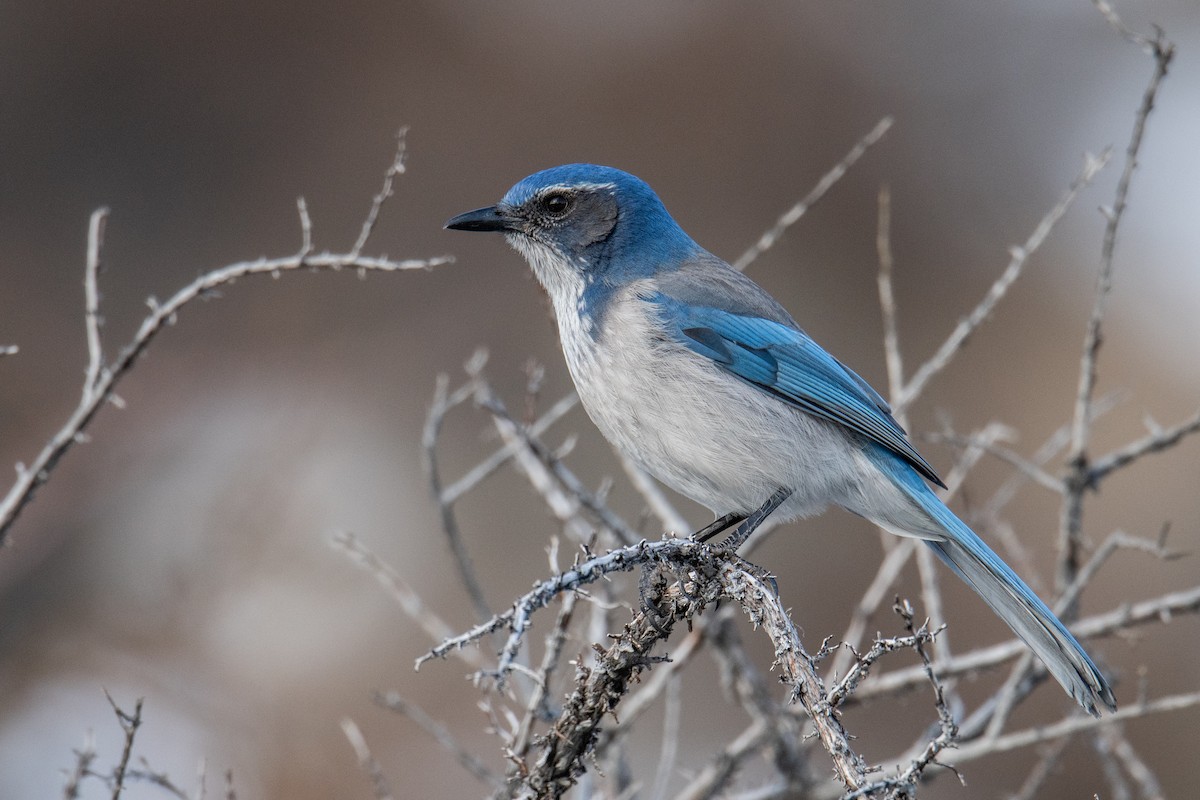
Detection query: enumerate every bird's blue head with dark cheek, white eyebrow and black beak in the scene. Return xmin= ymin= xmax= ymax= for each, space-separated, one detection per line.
xmin=445 ymin=164 xmax=700 ymax=296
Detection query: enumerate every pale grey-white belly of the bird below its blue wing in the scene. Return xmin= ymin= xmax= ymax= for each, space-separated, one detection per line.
xmin=564 ymin=326 xmax=862 ymax=517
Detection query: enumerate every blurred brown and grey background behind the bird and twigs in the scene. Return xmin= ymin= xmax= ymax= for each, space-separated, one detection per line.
xmin=0 ymin=0 xmax=1200 ymax=799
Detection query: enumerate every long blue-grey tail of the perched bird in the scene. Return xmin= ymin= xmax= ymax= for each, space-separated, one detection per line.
xmin=872 ymin=449 xmax=1116 ymax=716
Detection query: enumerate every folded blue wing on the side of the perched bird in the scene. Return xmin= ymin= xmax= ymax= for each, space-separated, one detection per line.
xmin=649 ymin=293 xmax=946 ymax=488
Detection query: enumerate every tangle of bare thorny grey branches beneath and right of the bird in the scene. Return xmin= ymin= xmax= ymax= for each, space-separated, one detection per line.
xmin=372 ymin=8 xmax=1200 ymax=799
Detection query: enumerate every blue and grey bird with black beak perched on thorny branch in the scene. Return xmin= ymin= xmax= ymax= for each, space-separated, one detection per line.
xmin=444 ymin=163 xmax=1116 ymax=716
